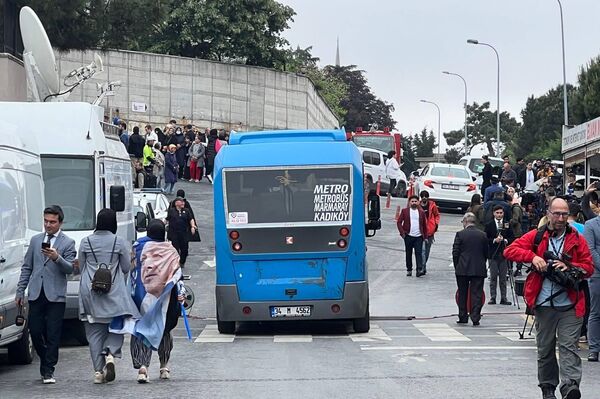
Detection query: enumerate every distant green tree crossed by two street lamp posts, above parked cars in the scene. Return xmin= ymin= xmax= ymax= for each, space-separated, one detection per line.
xmin=444 ymin=102 xmax=520 ymax=156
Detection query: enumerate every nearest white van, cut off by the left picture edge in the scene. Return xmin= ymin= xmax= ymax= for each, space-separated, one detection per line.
xmin=0 ymin=120 xmax=44 ymax=364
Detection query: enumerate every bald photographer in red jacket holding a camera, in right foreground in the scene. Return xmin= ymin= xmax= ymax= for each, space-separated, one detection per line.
xmin=504 ymin=198 xmax=594 ymax=399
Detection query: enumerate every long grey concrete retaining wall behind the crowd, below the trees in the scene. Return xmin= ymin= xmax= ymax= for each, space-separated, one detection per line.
xmin=56 ymin=51 xmax=339 ymax=131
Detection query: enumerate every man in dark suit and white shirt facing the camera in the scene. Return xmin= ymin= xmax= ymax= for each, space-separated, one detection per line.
xmin=485 ymin=205 xmax=514 ymax=305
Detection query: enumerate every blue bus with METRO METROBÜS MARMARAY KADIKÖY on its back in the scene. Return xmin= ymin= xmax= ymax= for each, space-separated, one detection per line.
xmin=214 ymin=130 xmax=381 ymax=334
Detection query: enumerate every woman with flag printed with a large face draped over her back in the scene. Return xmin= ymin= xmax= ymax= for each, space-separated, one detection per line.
xmin=130 ymin=219 xmax=184 ymax=383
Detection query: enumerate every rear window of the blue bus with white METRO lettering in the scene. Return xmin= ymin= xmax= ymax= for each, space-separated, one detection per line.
xmin=224 ymin=166 xmax=352 ymax=227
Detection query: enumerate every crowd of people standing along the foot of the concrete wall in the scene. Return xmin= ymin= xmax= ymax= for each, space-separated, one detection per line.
xmin=112 ymin=110 xmax=229 ymax=194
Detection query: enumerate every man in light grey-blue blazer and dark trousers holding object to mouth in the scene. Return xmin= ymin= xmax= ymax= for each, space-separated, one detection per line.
xmin=15 ymin=205 xmax=77 ymax=384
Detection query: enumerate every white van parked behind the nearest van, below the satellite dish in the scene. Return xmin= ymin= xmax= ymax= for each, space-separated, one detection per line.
xmin=0 ymin=102 xmax=135 ymax=342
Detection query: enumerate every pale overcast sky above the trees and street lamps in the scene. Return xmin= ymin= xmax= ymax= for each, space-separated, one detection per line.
xmin=279 ymin=0 xmax=600 ymax=153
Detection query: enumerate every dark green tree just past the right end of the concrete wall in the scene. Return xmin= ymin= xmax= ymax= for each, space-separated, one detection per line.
xmin=324 ymin=65 xmax=396 ymax=131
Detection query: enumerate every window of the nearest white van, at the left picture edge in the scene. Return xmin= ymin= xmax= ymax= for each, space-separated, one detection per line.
xmin=0 ymin=170 xmax=26 ymax=243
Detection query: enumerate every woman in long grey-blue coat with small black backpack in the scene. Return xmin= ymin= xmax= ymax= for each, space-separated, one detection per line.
xmin=79 ymin=209 xmax=140 ymax=384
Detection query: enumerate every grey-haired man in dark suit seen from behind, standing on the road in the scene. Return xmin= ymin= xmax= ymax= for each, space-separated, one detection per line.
xmin=452 ymin=212 xmax=488 ymax=326
